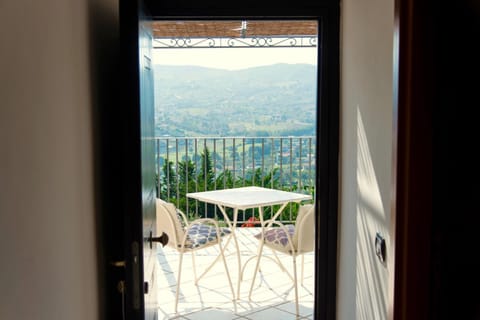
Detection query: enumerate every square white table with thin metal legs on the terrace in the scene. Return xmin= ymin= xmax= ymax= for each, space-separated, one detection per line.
xmin=187 ymin=187 xmax=312 ymax=299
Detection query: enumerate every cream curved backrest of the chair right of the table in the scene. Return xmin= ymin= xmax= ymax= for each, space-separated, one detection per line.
xmin=292 ymin=204 xmax=315 ymax=254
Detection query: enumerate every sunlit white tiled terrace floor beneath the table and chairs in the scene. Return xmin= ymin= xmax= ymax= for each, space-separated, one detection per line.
xmin=156 ymin=228 xmax=314 ymax=320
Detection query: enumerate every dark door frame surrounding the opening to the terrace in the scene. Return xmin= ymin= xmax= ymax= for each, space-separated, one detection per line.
xmin=106 ymin=0 xmax=340 ymax=320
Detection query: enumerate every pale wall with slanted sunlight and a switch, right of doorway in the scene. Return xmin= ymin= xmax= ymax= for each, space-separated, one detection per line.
xmin=337 ymin=0 xmax=394 ymax=320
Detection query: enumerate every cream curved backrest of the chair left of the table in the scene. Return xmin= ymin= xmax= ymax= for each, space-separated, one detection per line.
xmin=156 ymin=198 xmax=185 ymax=249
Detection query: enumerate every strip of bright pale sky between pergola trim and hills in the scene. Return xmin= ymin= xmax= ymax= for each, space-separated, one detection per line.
xmin=153 ymin=47 xmax=317 ymax=70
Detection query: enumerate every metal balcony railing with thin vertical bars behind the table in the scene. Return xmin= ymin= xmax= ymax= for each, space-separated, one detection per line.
xmin=155 ymin=136 xmax=316 ymax=223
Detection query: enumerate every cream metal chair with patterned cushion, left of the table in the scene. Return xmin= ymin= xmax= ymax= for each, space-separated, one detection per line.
xmin=156 ymin=198 xmax=236 ymax=312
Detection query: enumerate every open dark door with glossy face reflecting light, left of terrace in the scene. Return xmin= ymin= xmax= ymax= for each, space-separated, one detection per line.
xmin=116 ymin=0 xmax=156 ymax=320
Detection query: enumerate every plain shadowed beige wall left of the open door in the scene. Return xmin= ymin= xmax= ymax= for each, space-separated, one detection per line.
xmin=0 ymin=0 xmax=99 ymax=320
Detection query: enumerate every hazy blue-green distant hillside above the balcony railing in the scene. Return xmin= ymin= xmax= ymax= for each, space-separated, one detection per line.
xmin=154 ymin=64 xmax=317 ymax=136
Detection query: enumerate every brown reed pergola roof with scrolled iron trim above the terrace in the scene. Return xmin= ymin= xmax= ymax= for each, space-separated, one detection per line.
xmin=152 ymin=20 xmax=318 ymax=49
